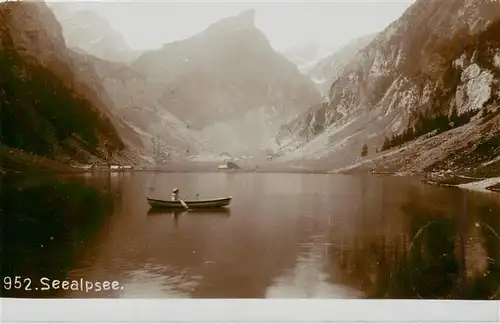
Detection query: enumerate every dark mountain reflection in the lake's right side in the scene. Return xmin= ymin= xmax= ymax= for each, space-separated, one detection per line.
xmin=330 ymin=178 xmax=500 ymax=299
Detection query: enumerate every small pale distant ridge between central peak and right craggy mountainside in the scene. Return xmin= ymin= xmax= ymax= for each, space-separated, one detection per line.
xmin=307 ymin=34 xmax=376 ymax=96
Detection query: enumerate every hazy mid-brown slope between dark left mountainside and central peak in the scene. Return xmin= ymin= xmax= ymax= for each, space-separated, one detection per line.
xmin=70 ymin=54 xmax=203 ymax=162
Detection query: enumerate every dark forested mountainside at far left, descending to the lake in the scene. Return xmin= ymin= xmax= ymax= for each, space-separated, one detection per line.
xmin=0 ymin=2 xmax=125 ymax=169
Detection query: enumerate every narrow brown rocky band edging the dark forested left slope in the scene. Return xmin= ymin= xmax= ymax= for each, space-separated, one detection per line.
xmin=1 ymin=2 xmax=156 ymax=159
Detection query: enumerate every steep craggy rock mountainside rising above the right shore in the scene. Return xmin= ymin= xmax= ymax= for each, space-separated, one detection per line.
xmin=278 ymin=0 xmax=500 ymax=175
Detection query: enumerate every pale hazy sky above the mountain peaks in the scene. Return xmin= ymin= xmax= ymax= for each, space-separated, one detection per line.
xmin=47 ymin=0 xmax=414 ymax=51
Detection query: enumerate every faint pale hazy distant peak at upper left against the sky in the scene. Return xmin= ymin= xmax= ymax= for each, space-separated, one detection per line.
xmin=50 ymin=2 xmax=141 ymax=63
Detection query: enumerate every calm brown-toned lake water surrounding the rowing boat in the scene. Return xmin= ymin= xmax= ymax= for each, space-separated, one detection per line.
xmin=1 ymin=172 xmax=500 ymax=299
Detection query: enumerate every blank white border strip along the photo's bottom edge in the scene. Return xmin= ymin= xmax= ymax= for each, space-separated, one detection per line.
xmin=0 ymin=298 xmax=500 ymax=323
